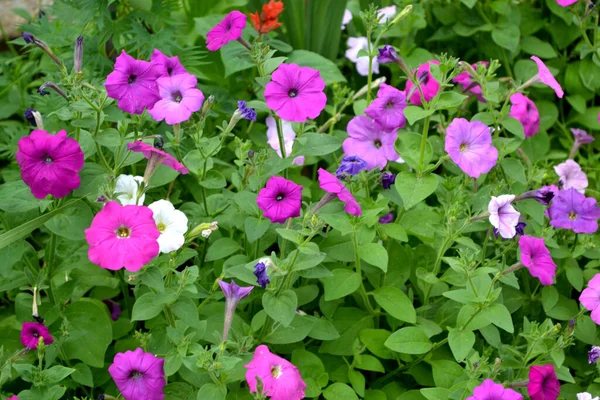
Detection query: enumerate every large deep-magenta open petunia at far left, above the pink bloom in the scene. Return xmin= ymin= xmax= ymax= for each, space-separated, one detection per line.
xmin=15 ymin=129 xmax=84 ymax=199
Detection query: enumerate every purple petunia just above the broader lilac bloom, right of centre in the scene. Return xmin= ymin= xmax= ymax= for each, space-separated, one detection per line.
xmin=365 ymin=83 xmax=406 ymax=131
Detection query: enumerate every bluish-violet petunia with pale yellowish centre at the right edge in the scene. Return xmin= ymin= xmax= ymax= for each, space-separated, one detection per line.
xmin=548 ymin=189 xmax=600 ymax=233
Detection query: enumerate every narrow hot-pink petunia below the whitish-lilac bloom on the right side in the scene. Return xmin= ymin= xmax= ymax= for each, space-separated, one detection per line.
xmin=519 ymin=235 xmax=556 ymax=285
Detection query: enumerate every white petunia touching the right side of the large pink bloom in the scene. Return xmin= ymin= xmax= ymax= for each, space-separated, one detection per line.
xmin=148 ymin=200 xmax=188 ymax=253
